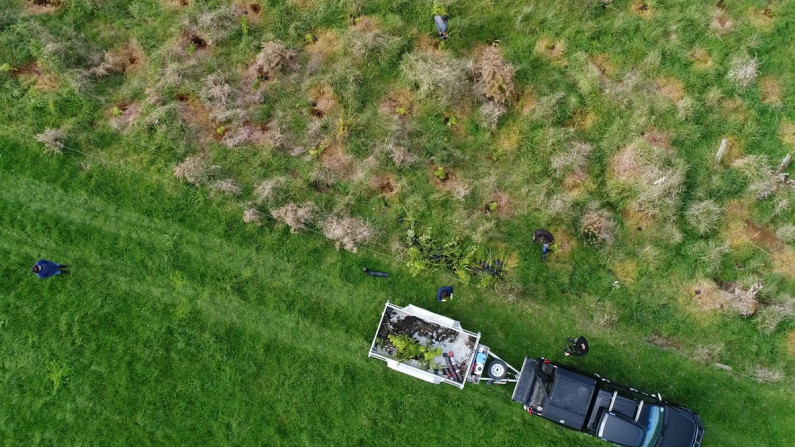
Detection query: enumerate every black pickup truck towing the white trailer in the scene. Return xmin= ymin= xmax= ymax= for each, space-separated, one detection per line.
xmin=511 ymin=357 xmax=704 ymax=447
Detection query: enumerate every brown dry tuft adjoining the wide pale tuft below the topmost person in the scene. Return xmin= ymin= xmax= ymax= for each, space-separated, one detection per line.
xmin=475 ymin=45 xmax=516 ymax=105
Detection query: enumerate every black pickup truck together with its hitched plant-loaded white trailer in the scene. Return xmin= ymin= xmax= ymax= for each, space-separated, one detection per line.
xmin=369 ymin=302 xmax=704 ymax=447
